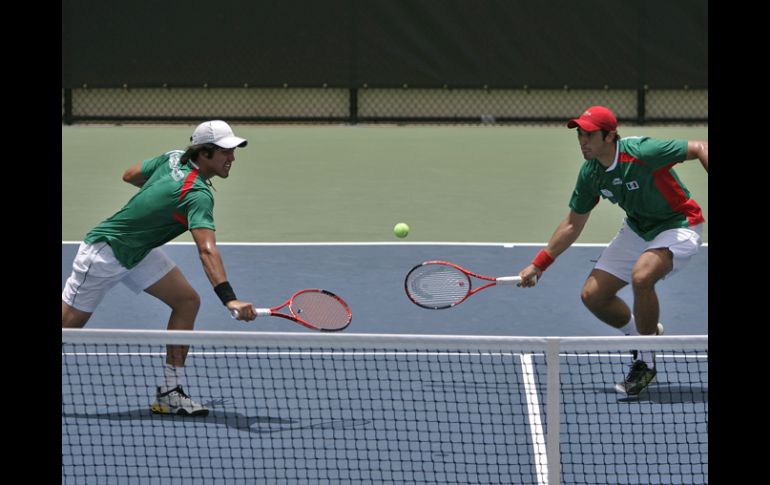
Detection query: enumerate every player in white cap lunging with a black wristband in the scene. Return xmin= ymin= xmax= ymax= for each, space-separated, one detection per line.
xmin=62 ymin=120 xmax=256 ymax=416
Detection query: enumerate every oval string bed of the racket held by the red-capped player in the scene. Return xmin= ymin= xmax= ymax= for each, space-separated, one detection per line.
xmin=406 ymin=265 xmax=471 ymax=307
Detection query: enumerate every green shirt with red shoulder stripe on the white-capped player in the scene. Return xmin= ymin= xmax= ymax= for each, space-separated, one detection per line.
xmin=84 ymin=150 xmax=215 ymax=269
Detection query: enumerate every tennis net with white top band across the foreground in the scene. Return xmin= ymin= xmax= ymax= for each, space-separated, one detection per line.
xmin=62 ymin=329 xmax=708 ymax=485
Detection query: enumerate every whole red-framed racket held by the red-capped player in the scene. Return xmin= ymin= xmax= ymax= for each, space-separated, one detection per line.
xmin=404 ymin=261 xmax=536 ymax=310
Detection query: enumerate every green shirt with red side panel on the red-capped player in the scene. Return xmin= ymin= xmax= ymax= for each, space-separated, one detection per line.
xmin=569 ymin=136 xmax=704 ymax=241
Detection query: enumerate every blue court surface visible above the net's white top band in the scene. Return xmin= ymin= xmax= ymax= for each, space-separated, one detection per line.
xmin=62 ymin=243 xmax=708 ymax=336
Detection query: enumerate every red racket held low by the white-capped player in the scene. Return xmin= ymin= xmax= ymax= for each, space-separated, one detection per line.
xmin=230 ymin=288 xmax=353 ymax=332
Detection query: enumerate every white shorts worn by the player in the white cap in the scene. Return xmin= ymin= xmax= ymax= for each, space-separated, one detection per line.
xmin=61 ymin=242 xmax=176 ymax=313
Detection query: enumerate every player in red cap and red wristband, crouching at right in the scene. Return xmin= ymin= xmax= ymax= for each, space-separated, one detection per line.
xmin=519 ymin=106 xmax=708 ymax=396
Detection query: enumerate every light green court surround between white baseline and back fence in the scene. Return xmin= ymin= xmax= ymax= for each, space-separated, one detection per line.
xmin=62 ymin=124 xmax=708 ymax=243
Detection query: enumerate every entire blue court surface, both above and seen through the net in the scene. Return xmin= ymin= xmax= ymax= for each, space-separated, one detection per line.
xmin=62 ymin=240 xmax=708 ymax=484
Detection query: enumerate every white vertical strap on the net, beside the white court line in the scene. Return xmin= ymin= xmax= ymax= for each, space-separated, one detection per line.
xmin=545 ymin=337 xmax=561 ymax=485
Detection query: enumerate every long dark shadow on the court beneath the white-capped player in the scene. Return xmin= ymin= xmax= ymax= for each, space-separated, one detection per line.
xmin=62 ymin=408 xmax=371 ymax=434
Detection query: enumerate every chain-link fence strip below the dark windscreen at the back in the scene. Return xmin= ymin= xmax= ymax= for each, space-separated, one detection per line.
xmin=62 ymin=86 xmax=708 ymax=124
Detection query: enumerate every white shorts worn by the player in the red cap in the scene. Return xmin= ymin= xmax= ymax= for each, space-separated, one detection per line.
xmin=594 ymin=220 xmax=703 ymax=283
